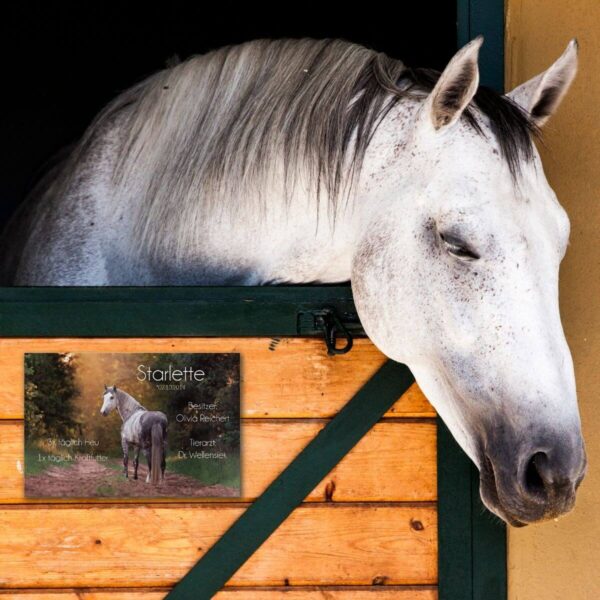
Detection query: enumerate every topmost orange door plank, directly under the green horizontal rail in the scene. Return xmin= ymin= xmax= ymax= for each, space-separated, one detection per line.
xmin=0 ymin=338 xmax=435 ymax=419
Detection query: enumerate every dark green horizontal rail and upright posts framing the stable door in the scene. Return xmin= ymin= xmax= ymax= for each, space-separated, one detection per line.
xmin=0 ymin=0 xmax=507 ymax=600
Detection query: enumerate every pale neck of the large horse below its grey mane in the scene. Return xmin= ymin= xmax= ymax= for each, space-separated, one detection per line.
xmin=111 ymin=100 xmax=416 ymax=285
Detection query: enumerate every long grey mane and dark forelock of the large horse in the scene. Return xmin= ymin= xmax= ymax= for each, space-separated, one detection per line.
xmin=62 ymin=39 xmax=535 ymax=254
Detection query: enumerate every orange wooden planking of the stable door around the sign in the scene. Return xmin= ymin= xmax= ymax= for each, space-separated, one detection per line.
xmin=0 ymin=338 xmax=438 ymax=600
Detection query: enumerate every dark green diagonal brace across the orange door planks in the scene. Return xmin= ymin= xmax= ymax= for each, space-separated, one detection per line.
xmin=167 ymin=361 xmax=414 ymax=600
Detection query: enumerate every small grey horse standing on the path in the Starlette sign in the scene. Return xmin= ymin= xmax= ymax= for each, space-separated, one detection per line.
xmin=100 ymin=385 xmax=167 ymax=485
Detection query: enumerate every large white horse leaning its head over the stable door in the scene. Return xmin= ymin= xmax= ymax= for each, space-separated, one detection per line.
xmin=3 ymin=38 xmax=586 ymax=525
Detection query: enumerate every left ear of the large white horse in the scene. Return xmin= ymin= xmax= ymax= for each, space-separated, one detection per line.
xmin=426 ymin=36 xmax=483 ymax=130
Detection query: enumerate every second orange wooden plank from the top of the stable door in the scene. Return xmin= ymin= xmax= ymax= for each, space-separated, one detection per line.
xmin=0 ymin=419 xmax=437 ymax=503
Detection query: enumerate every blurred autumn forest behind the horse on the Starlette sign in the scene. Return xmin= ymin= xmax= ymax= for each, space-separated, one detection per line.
xmin=25 ymin=353 xmax=240 ymax=485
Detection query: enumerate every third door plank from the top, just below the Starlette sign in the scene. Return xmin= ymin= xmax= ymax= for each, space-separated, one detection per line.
xmin=0 ymin=504 xmax=437 ymax=588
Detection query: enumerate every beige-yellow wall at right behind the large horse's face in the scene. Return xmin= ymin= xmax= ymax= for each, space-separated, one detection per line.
xmin=506 ymin=0 xmax=600 ymax=600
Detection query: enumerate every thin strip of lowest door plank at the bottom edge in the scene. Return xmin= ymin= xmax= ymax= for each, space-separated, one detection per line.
xmin=0 ymin=585 xmax=437 ymax=600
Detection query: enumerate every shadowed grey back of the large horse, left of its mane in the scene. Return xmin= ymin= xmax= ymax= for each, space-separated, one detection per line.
xmin=0 ymin=103 xmax=129 ymax=285
